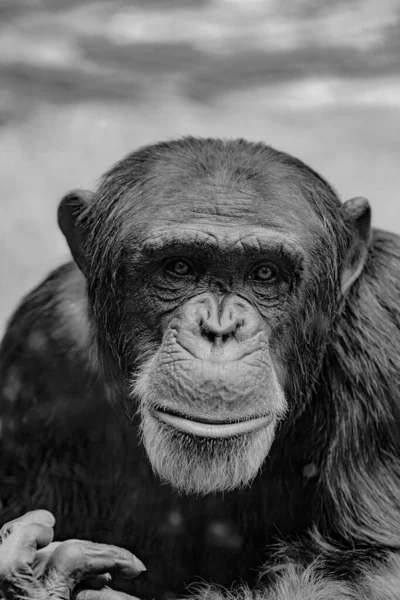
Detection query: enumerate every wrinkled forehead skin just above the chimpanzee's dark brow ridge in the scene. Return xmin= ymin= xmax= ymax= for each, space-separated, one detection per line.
xmin=134 ymin=166 xmax=322 ymax=238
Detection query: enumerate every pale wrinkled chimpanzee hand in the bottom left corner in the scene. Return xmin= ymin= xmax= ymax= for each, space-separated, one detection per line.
xmin=0 ymin=510 xmax=146 ymax=600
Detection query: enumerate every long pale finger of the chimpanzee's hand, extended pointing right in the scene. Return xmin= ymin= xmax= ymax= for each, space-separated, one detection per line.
xmin=48 ymin=540 xmax=146 ymax=582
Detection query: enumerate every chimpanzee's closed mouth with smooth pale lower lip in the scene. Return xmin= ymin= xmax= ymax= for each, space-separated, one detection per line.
xmin=150 ymin=407 xmax=273 ymax=438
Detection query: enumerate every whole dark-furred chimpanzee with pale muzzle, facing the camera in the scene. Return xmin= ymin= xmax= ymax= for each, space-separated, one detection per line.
xmin=0 ymin=137 xmax=400 ymax=600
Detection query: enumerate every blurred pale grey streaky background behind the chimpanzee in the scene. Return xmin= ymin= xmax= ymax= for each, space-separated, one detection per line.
xmin=0 ymin=0 xmax=400 ymax=329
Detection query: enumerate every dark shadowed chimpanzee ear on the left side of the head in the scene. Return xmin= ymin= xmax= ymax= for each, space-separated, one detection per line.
xmin=58 ymin=190 xmax=94 ymax=274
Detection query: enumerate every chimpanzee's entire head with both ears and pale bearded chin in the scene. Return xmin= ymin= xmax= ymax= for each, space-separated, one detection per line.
xmin=59 ymin=138 xmax=370 ymax=494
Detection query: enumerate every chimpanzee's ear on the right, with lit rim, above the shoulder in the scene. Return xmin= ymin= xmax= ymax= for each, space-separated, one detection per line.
xmin=341 ymin=198 xmax=371 ymax=294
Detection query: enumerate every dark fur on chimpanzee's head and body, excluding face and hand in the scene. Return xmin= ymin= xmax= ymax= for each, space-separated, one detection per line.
xmin=0 ymin=139 xmax=400 ymax=600
